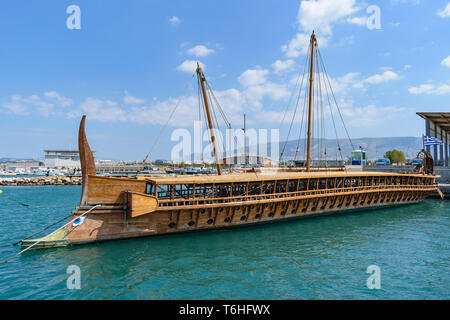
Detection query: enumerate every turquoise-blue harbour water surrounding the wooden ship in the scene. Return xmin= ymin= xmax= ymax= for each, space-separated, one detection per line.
xmin=0 ymin=186 xmax=450 ymax=299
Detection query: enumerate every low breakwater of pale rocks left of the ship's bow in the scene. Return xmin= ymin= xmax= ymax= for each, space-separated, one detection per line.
xmin=0 ymin=176 xmax=81 ymax=186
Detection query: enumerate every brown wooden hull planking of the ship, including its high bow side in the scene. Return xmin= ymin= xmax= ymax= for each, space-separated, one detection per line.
xmin=22 ymin=177 xmax=437 ymax=249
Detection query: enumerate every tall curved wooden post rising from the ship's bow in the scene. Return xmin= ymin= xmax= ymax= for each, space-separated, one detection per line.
xmin=78 ymin=115 xmax=95 ymax=206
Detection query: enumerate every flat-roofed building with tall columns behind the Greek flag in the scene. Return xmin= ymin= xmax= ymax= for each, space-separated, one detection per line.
xmin=417 ymin=112 xmax=450 ymax=167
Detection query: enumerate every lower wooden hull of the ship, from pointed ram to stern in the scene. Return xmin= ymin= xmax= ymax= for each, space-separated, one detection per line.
xmin=22 ymin=188 xmax=433 ymax=249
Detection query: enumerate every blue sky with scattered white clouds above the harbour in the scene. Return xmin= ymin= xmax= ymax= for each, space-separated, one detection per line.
xmin=0 ymin=0 xmax=450 ymax=160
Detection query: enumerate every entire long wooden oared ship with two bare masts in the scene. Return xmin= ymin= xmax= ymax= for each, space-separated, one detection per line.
xmin=22 ymin=32 xmax=439 ymax=249
